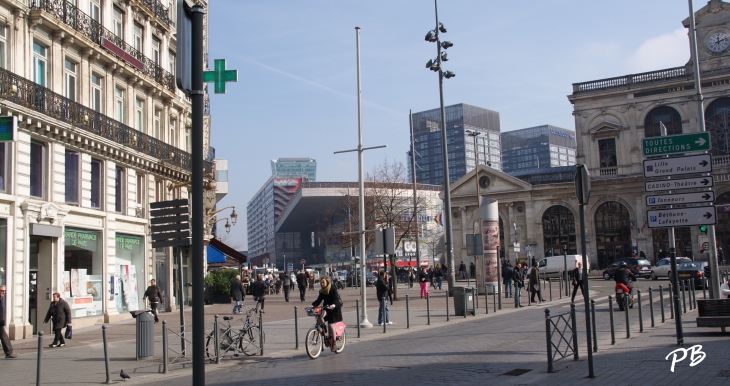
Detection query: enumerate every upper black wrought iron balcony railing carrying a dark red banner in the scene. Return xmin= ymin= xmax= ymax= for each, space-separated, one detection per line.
xmin=31 ymin=0 xmax=176 ymax=92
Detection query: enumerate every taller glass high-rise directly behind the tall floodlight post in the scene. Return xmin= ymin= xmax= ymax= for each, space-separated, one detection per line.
xmin=408 ymin=103 xmax=502 ymax=185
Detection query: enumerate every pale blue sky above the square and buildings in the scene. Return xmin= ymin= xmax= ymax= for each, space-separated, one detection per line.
xmin=203 ymin=0 xmax=707 ymax=250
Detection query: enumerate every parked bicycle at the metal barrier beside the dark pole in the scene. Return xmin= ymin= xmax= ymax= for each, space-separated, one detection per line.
xmin=205 ymin=303 xmax=266 ymax=361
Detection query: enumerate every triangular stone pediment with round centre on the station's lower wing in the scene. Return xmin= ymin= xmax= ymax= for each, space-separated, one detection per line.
xmin=451 ymin=165 xmax=532 ymax=197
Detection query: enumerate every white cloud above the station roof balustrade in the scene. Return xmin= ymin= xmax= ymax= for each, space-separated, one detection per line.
xmin=626 ymin=28 xmax=690 ymax=73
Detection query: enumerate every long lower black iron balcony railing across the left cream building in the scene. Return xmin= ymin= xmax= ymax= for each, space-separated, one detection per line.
xmin=0 ymin=69 xmax=213 ymax=173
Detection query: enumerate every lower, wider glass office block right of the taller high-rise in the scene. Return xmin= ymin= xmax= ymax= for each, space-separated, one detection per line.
xmin=502 ymin=125 xmax=576 ymax=173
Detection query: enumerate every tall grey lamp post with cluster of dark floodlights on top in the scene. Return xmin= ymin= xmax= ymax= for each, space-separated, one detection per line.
xmin=426 ymin=0 xmax=456 ymax=294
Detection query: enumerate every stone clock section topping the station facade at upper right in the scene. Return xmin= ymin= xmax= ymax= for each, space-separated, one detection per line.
xmin=682 ymin=0 xmax=730 ymax=72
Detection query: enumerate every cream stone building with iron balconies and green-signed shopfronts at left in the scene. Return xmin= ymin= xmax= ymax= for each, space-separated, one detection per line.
xmin=0 ymin=0 xmax=212 ymax=339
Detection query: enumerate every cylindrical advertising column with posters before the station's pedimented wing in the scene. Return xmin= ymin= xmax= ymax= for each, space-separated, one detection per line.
xmin=479 ymin=197 xmax=499 ymax=293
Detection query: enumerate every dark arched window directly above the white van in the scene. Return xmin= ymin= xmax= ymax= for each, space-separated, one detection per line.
xmin=542 ymin=205 xmax=578 ymax=257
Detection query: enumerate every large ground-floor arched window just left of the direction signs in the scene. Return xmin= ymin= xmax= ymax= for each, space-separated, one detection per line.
xmin=595 ymin=201 xmax=632 ymax=268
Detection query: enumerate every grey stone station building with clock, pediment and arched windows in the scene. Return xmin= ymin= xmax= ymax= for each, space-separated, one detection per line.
xmin=451 ymin=0 xmax=730 ymax=269
